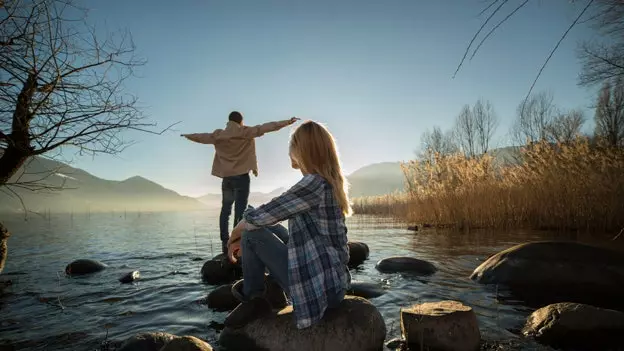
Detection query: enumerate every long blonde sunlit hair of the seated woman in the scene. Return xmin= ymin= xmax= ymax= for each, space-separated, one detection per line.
xmin=290 ymin=121 xmax=353 ymax=216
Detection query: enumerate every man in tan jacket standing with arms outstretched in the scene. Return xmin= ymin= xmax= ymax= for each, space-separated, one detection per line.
xmin=182 ymin=111 xmax=299 ymax=254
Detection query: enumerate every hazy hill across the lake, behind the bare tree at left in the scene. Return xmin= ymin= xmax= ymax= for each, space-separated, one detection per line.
xmin=0 ymin=157 xmax=205 ymax=212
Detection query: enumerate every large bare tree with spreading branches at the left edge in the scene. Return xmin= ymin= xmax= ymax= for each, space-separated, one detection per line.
xmin=0 ymin=0 xmax=174 ymax=271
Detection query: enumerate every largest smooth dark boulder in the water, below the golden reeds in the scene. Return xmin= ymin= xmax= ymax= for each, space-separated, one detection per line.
xmin=470 ymin=241 xmax=624 ymax=307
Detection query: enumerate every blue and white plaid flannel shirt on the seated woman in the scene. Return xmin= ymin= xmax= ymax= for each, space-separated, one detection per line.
xmin=243 ymin=174 xmax=351 ymax=329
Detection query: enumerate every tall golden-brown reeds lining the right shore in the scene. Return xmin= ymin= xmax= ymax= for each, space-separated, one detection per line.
xmin=354 ymin=139 xmax=624 ymax=232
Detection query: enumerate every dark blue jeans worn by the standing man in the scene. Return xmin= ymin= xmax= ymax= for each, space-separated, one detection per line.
xmin=219 ymin=173 xmax=250 ymax=253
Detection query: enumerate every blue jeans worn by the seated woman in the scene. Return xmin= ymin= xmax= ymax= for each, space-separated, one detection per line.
xmin=241 ymin=224 xmax=346 ymax=308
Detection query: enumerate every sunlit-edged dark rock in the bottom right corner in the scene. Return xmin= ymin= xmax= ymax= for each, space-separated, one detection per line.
xmin=522 ymin=302 xmax=624 ymax=350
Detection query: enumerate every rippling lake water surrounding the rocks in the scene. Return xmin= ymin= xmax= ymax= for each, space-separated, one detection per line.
xmin=0 ymin=212 xmax=622 ymax=350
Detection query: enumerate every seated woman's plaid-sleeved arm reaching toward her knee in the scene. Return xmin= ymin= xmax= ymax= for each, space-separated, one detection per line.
xmin=243 ymin=174 xmax=326 ymax=227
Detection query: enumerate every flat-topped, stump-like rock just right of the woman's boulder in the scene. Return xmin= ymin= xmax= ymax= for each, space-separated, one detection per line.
xmin=401 ymin=301 xmax=481 ymax=351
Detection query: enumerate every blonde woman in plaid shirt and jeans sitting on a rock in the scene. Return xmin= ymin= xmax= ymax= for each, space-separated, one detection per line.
xmin=225 ymin=121 xmax=351 ymax=329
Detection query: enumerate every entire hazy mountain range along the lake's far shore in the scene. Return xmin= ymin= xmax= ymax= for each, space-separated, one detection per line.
xmin=0 ymin=147 xmax=518 ymax=212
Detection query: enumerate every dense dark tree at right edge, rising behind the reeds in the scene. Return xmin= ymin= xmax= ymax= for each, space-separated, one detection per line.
xmin=594 ymin=77 xmax=624 ymax=147
